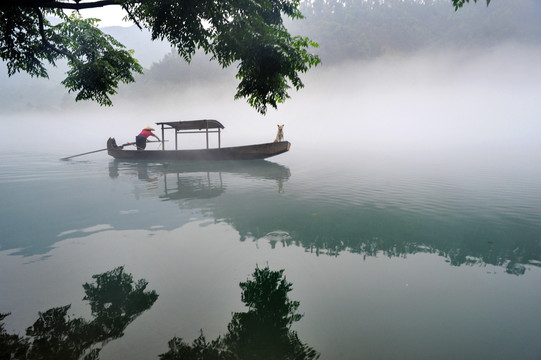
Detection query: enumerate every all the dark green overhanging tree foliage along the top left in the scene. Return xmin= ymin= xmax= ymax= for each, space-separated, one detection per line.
xmin=0 ymin=0 xmax=320 ymax=114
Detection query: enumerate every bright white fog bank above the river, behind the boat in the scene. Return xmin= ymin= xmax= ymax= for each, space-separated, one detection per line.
xmin=0 ymin=44 xmax=541 ymax=170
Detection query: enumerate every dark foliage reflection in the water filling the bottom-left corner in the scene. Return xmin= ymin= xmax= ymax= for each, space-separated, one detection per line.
xmin=0 ymin=267 xmax=158 ymax=360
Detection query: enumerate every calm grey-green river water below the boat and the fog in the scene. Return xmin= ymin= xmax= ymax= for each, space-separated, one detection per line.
xmin=0 ymin=144 xmax=541 ymax=359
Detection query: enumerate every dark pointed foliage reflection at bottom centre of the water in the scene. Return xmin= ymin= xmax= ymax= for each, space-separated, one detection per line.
xmin=160 ymin=267 xmax=319 ymax=360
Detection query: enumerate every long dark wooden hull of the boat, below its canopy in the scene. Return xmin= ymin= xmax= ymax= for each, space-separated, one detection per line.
xmin=107 ymin=138 xmax=291 ymax=161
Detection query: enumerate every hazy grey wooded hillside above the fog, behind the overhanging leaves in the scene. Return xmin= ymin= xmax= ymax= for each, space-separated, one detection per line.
xmin=122 ymin=0 xmax=541 ymax=92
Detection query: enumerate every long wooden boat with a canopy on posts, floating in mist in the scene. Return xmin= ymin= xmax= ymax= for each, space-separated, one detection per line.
xmin=107 ymin=120 xmax=291 ymax=161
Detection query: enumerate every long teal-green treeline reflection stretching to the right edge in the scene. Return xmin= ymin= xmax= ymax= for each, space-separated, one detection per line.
xmin=212 ymin=190 xmax=541 ymax=275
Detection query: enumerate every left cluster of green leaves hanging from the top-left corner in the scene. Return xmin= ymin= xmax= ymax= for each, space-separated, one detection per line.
xmin=0 ymin=5 xmax=142 ymax=105
